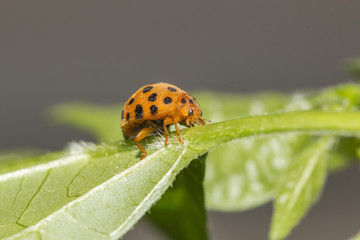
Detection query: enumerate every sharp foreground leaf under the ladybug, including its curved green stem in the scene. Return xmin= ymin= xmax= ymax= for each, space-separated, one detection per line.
xmin=0 ymin=111 xmax=360 ymax=239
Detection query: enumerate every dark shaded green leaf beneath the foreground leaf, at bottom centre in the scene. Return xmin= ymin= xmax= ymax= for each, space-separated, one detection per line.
xmin=148 ymin=154 xmax=207 ymax=240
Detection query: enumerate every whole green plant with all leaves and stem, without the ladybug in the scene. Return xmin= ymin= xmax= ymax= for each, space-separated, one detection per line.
xmin=0 ymin=84 xmax=360 ymax=239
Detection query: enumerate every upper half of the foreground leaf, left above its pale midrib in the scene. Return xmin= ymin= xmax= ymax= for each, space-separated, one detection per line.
xmin=0 ymin=143 xmax=137 ymax=237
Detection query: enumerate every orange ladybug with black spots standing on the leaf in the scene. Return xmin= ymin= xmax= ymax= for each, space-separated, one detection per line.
xmin=121 ymin=83 xmax=205 ymax=159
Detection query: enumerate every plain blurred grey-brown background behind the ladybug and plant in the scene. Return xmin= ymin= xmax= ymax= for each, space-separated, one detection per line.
xmin=0 ymin=0 xmax=360 ymax=240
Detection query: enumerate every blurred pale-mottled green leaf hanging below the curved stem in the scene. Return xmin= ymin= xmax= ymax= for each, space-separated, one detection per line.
xmin=205 ymin=133 xmax=313 ymax=211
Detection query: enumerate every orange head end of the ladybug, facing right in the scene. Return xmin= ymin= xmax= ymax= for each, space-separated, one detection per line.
xmin=178 ymin=94 xmax=205 ymax=127
